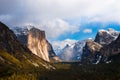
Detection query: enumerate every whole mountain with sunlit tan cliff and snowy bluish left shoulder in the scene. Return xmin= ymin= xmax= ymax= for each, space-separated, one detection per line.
xmin=13 ymin=26 xmax=60 ymax=62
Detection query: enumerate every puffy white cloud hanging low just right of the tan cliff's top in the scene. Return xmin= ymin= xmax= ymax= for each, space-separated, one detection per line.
xmin=39 ymin=19 xmax=79 ymax=38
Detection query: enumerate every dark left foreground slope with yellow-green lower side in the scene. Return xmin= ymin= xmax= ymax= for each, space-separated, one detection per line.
xmin=0 ymin=22 xmax=53 ymax=70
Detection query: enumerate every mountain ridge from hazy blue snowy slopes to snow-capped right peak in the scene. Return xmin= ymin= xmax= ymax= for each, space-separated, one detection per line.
xmin=56 ymin=28 xmax=120 ymax=64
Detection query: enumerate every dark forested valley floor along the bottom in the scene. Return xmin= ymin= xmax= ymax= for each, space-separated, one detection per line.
xmin=0 ymin=63 xmax=120 ymax=80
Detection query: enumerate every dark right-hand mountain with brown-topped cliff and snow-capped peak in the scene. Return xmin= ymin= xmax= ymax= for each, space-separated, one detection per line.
xmin=82 ymin=29 xmax=119 ymax=64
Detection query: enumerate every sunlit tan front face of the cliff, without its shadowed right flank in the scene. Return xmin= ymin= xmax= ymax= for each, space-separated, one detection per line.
xmin=28 ymin=28 xmax=50 ymax=61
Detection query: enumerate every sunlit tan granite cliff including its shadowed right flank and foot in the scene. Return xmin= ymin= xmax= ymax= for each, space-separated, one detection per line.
xmin=27 ymin=28 xmax=59 ymax=62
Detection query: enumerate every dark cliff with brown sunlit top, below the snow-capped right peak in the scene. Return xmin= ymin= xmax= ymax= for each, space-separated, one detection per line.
xmin=81 ymin=40 xmax=102 ymax=64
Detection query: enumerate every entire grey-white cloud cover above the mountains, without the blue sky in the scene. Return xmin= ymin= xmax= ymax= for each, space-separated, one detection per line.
xmin=0 ymin=0 xmax=120 ymax=38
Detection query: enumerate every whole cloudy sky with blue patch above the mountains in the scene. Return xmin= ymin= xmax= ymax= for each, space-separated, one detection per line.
xmin=0 ymin=0 xmax=120 ymax=48
